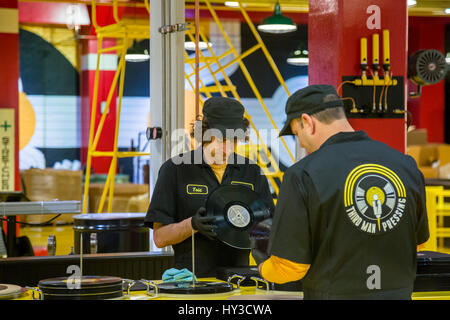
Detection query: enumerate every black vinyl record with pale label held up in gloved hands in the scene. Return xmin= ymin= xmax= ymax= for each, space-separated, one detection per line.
xmin=206 ymin=185 xmax=270 ymax=249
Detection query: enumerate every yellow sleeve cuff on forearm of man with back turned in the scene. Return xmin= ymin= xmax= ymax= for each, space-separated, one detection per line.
xmin=260 ymin=256 xmax=310 ymax=284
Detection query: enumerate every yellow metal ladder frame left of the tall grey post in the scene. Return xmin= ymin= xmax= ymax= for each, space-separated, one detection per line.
xmin=82 ymin=0 xmax=150 ymax=213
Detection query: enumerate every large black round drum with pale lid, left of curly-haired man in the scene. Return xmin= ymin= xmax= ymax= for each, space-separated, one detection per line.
xmin=73 ymin=213 xmax=150 ymax=254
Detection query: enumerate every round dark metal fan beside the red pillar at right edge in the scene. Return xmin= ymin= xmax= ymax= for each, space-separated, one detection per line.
xmin=408 ymin=49 xmax=447 ymax=96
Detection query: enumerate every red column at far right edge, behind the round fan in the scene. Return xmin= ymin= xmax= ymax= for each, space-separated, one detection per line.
xmin=408 ymin=17 xmax=448 ymax=143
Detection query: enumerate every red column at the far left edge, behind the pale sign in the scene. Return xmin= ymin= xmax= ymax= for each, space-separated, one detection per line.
xmin=0 ymin=0 xmax=20 ymax=191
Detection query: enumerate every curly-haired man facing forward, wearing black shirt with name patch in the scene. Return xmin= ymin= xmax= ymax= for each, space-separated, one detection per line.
xmin=144 ymin=97 xmax=274 ymax=277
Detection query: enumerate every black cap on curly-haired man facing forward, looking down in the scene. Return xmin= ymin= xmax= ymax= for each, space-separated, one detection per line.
xmin=203 ymin=97 xmax=245 ymax=138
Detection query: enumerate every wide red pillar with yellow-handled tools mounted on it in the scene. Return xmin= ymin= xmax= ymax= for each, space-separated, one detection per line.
xmin=308 ymin=0 xmax=408 ymax=152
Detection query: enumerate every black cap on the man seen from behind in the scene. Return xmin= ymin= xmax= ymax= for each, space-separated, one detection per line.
xmin=280 ymin=85 xmax=344 ymax=137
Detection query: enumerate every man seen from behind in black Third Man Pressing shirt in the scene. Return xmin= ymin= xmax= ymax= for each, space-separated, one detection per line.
xmin=252 ymin=85 xmax=429 ymax=299
